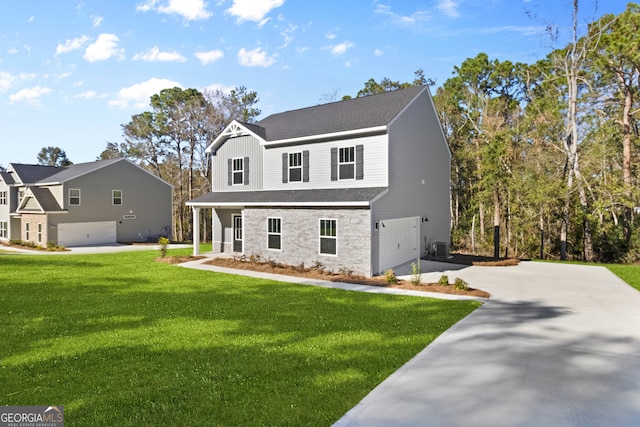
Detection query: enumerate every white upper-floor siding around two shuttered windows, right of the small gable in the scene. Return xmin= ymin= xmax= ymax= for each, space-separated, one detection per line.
xmin=262 ymin=135 xmax=388 ymax=190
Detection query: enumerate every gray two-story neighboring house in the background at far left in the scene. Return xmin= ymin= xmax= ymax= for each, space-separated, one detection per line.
xmin=0 ymin=158 xmax=173 ymax=246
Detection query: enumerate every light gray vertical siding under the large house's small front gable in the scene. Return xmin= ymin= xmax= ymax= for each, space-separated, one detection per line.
xmin=211 ymin=135 xmax=262 ymax=191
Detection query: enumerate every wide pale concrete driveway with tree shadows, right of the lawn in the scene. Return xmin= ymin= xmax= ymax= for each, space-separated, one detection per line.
xmin=335 ymin=262 xmax=640 ymax=427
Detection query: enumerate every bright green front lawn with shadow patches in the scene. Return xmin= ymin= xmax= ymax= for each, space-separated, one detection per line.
xmin=0 ymin=250 xmax=478 ymax=426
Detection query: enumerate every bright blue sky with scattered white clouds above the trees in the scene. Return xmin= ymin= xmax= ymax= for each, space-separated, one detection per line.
xmin=0 ymin=0 xmax=627 ymax=166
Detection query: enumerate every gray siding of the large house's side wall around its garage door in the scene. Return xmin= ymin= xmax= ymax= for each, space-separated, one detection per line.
xmin=372 ymin=91 xmax=451 ymax=272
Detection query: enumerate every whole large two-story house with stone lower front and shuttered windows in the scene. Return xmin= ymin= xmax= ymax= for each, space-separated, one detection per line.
xmin=187 ymin=86 xmax=451 ymax=276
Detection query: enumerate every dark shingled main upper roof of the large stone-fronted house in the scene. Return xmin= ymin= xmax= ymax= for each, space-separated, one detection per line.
xmin=255 ymin=86 xmax=428 ymax=141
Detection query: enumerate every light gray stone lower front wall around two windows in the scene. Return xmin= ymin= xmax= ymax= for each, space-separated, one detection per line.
xmin=243 ymin=208 xmax=371 ymax=276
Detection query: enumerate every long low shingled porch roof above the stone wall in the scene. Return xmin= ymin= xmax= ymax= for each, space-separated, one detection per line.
xmin=187 ymin=187 xmax=387 ymax=206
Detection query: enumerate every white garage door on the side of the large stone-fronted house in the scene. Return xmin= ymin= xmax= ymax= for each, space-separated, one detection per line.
xmin=378 ymin=217 xmax=420 ymax=271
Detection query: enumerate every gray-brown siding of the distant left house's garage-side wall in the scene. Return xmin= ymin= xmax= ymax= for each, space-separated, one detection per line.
xmin=49 ymin=161 xmax=172 ymax=242
